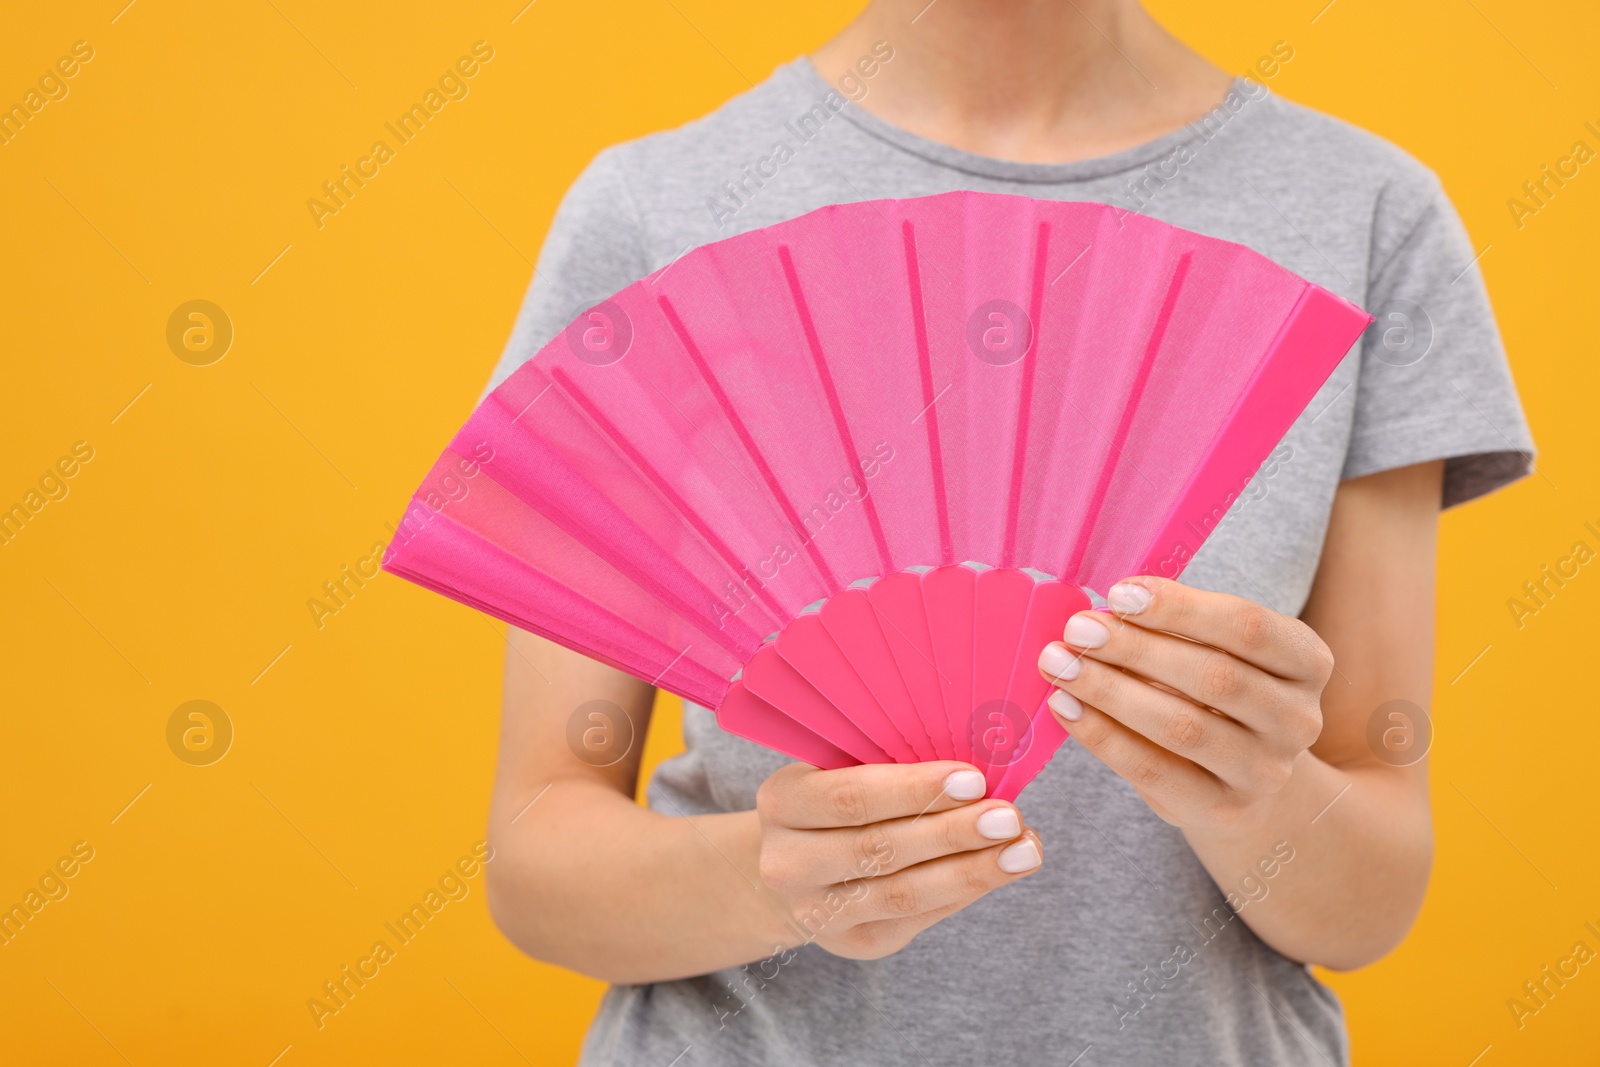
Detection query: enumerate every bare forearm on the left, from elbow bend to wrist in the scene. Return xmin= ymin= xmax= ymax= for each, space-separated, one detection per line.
xmin=488 ymin=777 xmax=802 ymax=984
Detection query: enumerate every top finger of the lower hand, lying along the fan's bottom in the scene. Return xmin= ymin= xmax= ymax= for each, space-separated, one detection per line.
xmin=755 ymin=760 xmax=987 ymax=830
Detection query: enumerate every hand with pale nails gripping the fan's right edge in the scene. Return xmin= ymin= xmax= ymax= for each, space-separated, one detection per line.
xmin=1038 ymin=577 xmax=1333 ymax=829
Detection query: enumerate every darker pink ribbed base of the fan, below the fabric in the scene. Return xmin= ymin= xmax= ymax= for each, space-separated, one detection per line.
xmin=717 ymin=565 xmax=1091 ymax=800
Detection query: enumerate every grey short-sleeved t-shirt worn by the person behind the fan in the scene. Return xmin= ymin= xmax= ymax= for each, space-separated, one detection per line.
xmin=493 ymin=59 xmax=1533 ymax=1067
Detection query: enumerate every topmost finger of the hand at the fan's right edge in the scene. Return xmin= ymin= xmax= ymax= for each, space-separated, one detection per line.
xmin=1107 ymin=574 xmax=1333 ymax=681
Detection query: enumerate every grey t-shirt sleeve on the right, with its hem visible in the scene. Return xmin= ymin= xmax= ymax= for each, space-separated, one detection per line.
xmin=1344 ymin=166 xmax=1534 ymax=507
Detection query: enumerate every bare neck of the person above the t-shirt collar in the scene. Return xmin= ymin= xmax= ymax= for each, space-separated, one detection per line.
xmin=811 ymin=0 xmax=1232 ymax=163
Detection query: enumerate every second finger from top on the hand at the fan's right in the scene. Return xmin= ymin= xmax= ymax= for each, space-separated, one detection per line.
xmin=1040 ymin=611 xmax=1283 ymax=729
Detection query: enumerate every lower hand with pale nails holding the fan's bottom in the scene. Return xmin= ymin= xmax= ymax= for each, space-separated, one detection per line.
xmin=755 ymin=761 xmax=1043 ymax=960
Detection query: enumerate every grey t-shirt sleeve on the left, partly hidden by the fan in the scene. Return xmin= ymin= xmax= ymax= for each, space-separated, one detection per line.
xmin=480 ymin=147 xmax=650 ymax=400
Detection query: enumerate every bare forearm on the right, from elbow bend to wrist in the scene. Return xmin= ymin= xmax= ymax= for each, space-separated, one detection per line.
xmin=1184 ymin=752 xmax=1434 ymax=969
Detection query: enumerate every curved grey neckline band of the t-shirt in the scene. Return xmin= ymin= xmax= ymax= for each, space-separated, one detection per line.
xmin=779 ymin=56 xmax=1264 ymax=182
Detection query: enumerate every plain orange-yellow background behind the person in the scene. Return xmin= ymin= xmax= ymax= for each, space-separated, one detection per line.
xmin=0 ymin=0 xmax=1600 ymax=1067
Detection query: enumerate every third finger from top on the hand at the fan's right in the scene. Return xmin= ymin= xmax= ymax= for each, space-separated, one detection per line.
xmin=1040 ymin=645 xmax=1261 ymax=787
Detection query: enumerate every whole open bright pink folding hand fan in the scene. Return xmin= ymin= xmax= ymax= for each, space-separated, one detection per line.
xmin=384 ymin=192 xmax=1371 ymax=800
